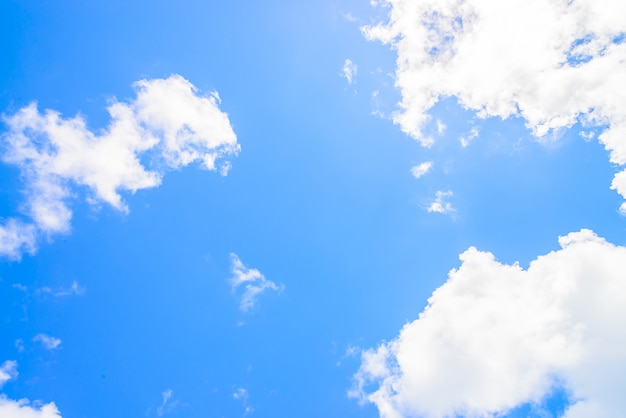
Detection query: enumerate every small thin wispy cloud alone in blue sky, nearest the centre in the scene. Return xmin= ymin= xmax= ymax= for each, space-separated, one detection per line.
xmin=230 ymin=253 xmax=284 ymax=312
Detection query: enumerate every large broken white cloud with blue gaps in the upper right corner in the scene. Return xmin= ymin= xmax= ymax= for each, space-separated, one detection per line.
xmin=362 ymin=0 xmax=626 ymax=211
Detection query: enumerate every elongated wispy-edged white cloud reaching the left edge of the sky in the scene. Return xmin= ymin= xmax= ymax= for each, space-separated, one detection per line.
xmin=0 ymin=75 xmax=239 ymax=258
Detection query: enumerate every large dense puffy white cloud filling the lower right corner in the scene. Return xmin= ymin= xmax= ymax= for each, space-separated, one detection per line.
xmin=351 ymin=230 xmax=626 ymax=418
